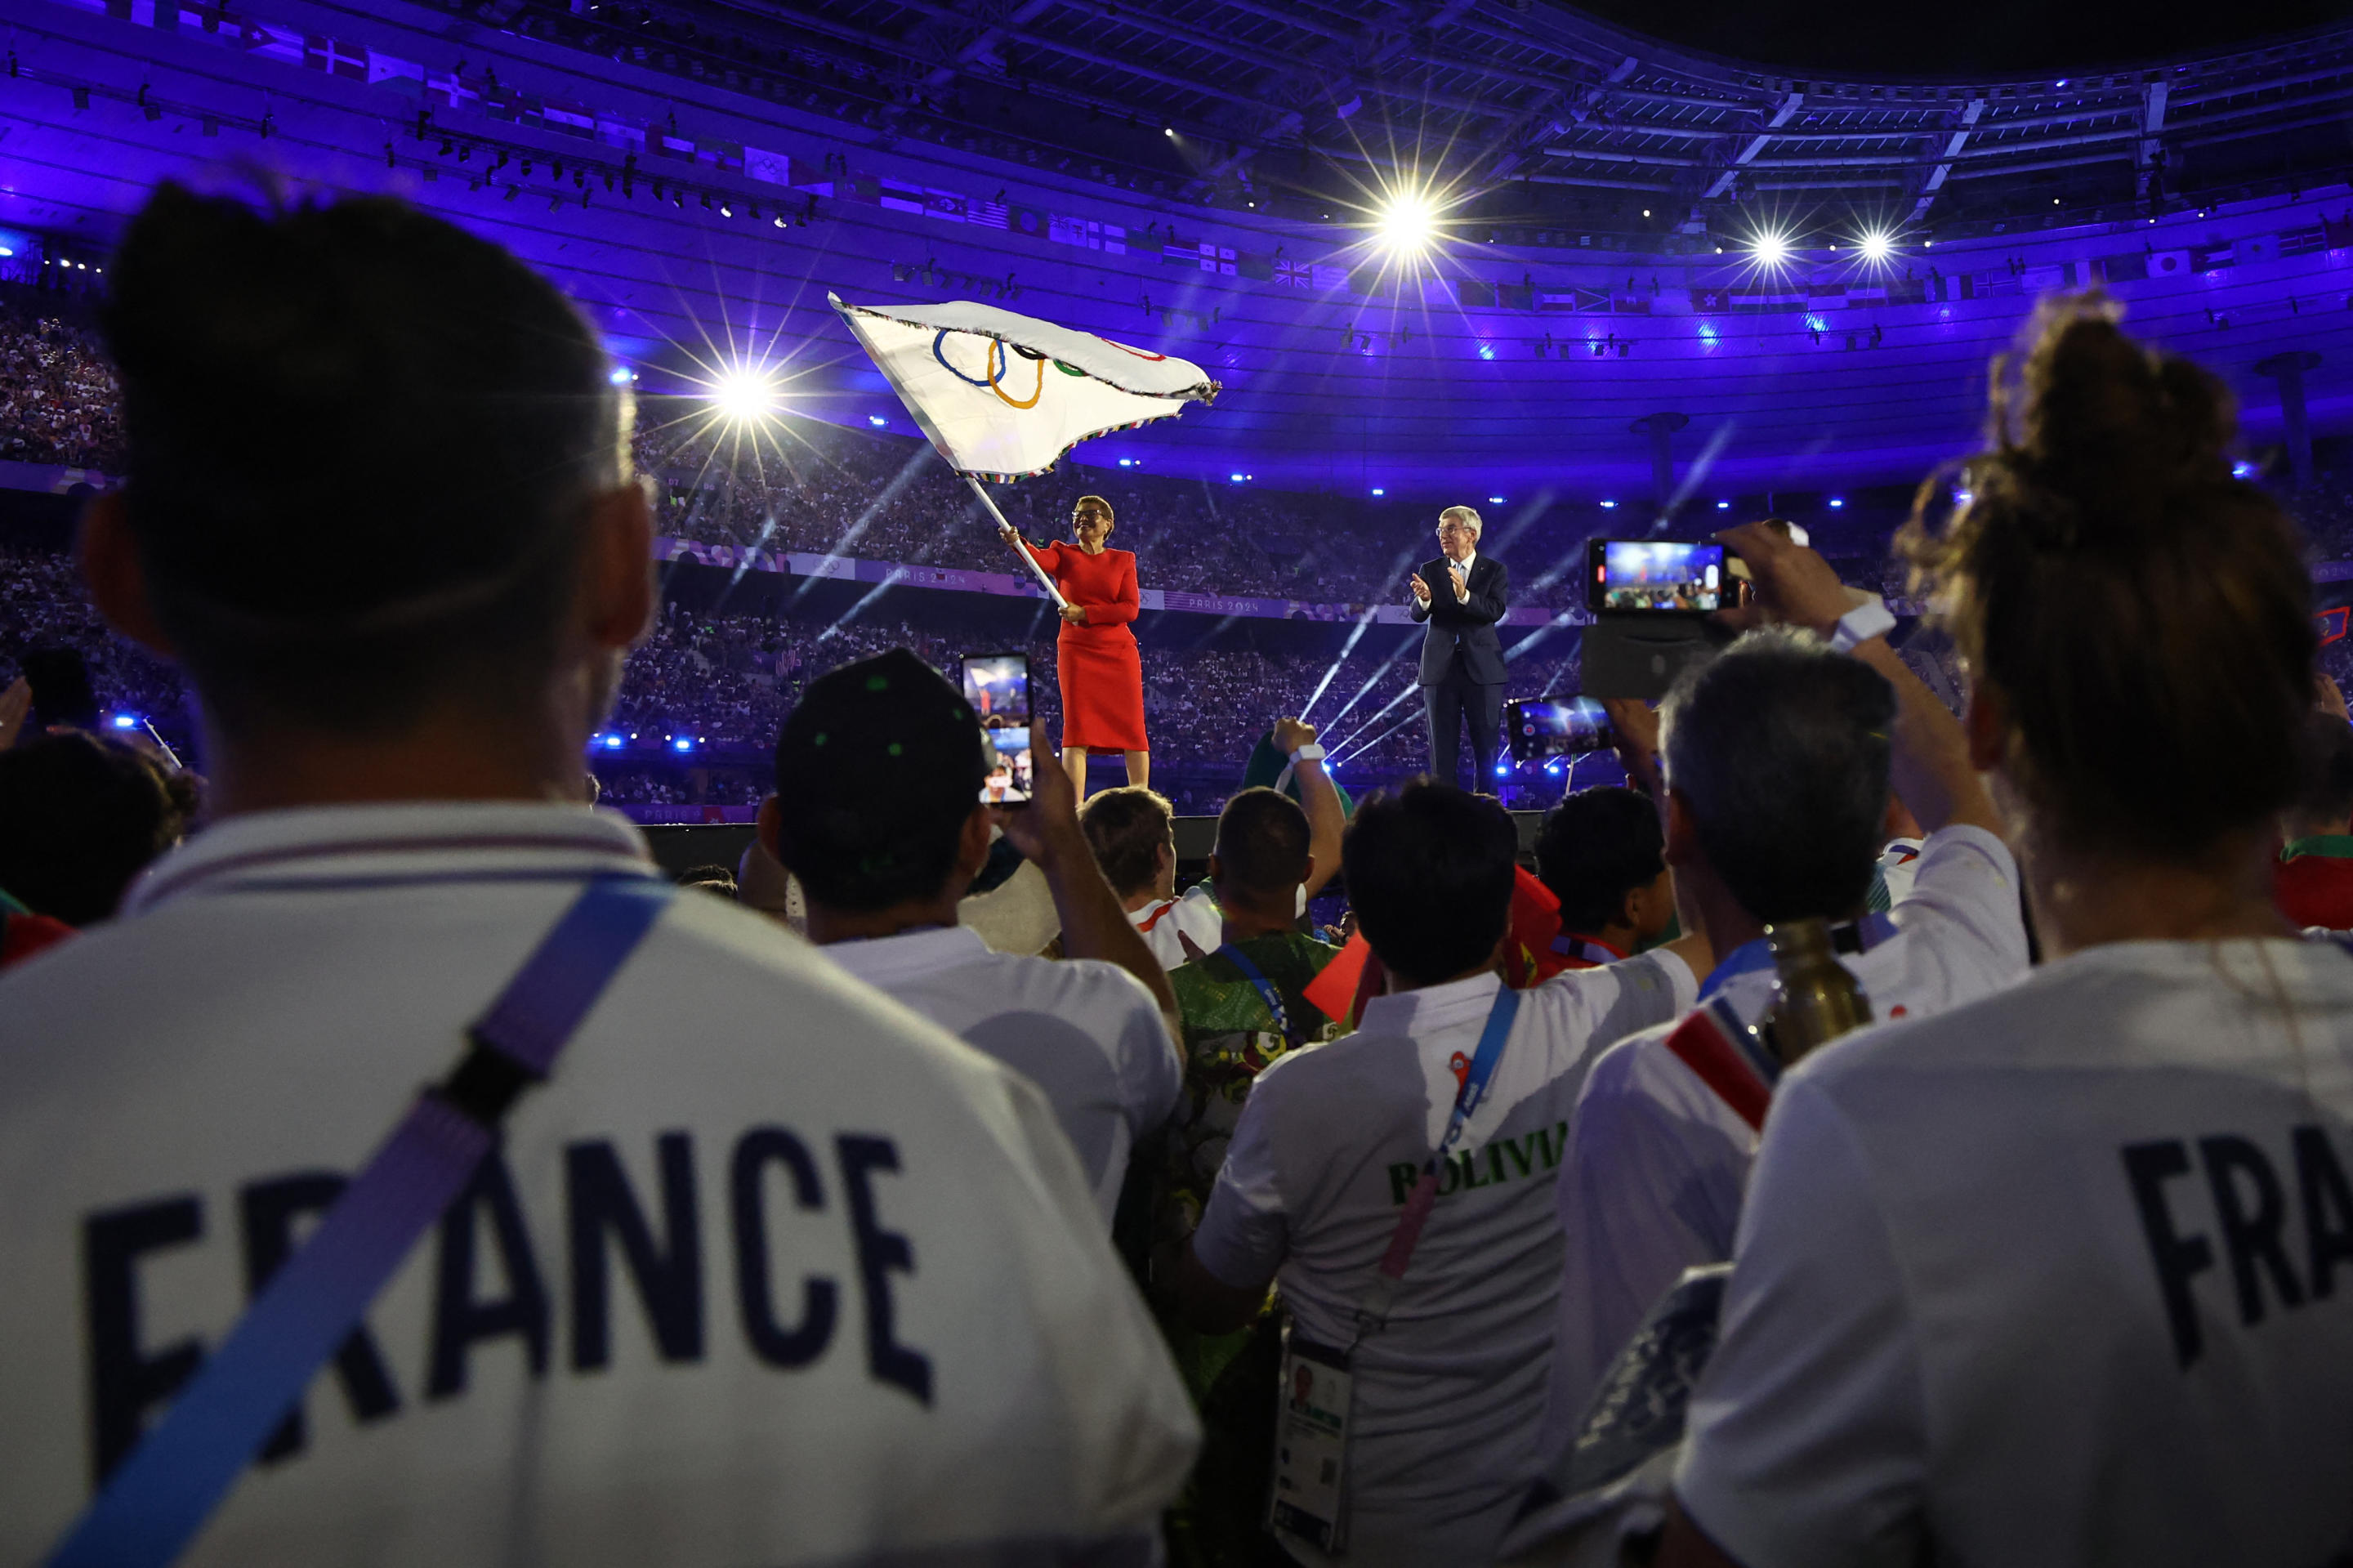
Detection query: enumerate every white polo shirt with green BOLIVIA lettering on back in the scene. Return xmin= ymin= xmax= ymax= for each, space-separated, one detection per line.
xmin=1193 ymin=951 xmax=1694 ymax=1566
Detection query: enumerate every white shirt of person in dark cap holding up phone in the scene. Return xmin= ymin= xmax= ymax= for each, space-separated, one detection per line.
xmin=819 ymin=925 xmax=1184 ymax=1229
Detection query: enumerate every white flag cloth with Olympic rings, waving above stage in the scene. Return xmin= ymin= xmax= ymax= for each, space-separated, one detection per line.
xmin=826 ymin=294 xmax=1219 ymax=480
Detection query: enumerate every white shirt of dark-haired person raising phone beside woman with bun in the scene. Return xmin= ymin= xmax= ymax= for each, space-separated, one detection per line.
xmin=1541 ymin=826 xmax=2026 ymax=1453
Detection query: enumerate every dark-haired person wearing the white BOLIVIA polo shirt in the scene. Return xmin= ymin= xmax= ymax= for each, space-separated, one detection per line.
xmin=1179 ymin=782 xmax=1706 ymax=1566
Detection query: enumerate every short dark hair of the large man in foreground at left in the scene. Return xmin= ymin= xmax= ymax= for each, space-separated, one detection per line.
xmin=106 ymin=181 xmax=628 ymax=732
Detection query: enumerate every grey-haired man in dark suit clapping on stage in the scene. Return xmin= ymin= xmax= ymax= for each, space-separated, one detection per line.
xmin=1407 ymin=506 xmax=1511 ymax=793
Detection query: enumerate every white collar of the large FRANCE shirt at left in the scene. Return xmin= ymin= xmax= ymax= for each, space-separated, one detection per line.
xmin=123 ymin=801 xmax=659 ymax=918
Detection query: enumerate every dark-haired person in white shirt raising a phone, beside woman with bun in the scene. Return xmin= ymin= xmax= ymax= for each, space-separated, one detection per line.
xmin=1543 ymin=525 xmax=2026 ymax=1453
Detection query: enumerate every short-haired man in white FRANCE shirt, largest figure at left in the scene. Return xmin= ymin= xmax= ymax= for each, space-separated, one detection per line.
xmin=0 ymin=186 xmax=1195 ymax=1568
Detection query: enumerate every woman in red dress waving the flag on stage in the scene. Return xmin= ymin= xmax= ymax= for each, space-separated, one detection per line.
xmin=1005 ymin=494 xmax=1153 ymax=801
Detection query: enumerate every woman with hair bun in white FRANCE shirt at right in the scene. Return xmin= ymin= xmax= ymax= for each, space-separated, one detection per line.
xmin=1657 ymin=297 xmax=2353 ymax=1568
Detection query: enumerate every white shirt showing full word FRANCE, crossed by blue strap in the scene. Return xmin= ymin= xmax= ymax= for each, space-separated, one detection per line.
xmin=0 ymin=803 xmax=1198 ymax=1568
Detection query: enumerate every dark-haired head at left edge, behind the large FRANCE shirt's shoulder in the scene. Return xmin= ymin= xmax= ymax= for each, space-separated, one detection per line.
xmin=0 ymin=730 xmax=195 ymax=925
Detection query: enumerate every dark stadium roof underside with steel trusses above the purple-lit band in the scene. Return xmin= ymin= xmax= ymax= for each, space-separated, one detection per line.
xmin=525 ymin=0 xmax=2353 ymax=221
